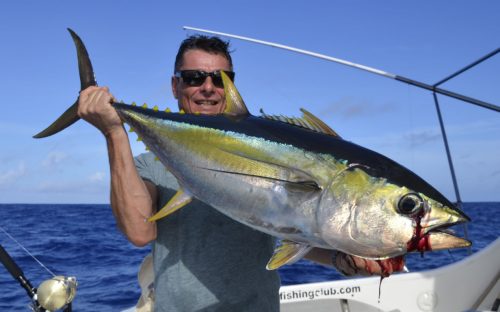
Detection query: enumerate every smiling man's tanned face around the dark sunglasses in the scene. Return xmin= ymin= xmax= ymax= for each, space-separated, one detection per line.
xmin=172 ymin=50 xmax=231 ymax=115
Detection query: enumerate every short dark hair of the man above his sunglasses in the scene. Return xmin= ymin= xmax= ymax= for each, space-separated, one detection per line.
xmin=174 ymin=35 xmax=233 ymax=71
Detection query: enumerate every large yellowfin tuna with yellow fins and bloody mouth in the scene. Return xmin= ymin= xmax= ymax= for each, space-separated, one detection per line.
xmin=35 ymin=30 xmax=470 ymax=269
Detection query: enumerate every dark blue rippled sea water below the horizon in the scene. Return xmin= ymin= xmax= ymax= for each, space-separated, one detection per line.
xmin=0 ymin=203 xmax=500 ymax=311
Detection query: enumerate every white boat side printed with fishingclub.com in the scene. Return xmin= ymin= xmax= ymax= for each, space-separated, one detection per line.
xmin=280 ymin=238 xmax=500 ymax=312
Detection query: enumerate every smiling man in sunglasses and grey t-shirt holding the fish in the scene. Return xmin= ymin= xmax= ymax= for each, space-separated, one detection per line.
xmin=78 ymin=36 xmax=400 ymax=311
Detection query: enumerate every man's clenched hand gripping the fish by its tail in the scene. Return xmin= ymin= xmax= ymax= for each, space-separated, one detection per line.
xmin=78 ymin=86 xmax=123 ymax=137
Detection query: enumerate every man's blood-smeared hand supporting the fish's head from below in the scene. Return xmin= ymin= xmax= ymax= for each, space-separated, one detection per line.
xmin=332 ymin=251 xmax=405 ymax=277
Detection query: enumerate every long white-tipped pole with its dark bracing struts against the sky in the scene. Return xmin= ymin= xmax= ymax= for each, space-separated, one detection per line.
xmin=183 ymin=26 xmax=500 ymax=254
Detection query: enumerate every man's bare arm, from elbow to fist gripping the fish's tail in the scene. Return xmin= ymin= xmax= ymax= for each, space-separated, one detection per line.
xmin=78 ymin=87 xmax=157 ymax=246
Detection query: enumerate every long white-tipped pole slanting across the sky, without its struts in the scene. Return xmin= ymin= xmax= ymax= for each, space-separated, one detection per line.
xmin=183 ymin=26 xmax=500 ymax=112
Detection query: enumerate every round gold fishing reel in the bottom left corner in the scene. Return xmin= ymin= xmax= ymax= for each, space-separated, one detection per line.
xmin=33 ymin=276 xmax=77 ymax=311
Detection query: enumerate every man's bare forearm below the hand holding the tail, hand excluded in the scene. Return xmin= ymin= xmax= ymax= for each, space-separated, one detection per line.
xmin=105 ymin=128 xmax=156 ymax=246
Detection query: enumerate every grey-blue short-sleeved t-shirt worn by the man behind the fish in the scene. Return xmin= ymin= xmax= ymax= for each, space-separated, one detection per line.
xmin=135 ymin=153 xmax=280 ymax=312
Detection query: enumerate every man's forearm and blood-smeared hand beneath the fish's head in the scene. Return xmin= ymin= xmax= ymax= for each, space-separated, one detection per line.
xmin=305 ymin=248 xmax=404 ymax=276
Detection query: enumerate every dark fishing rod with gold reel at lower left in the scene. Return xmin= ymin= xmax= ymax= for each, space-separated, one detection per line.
xmin=0 ymin=227 xmax=77 ymax=312
